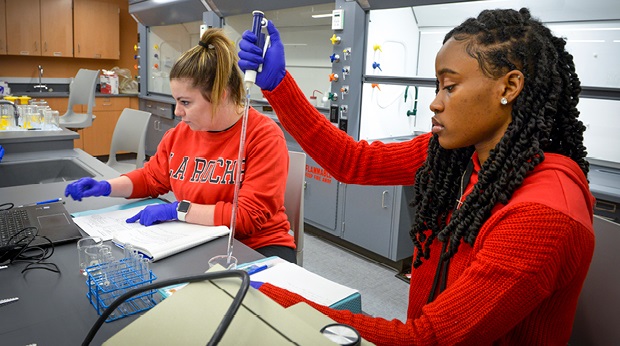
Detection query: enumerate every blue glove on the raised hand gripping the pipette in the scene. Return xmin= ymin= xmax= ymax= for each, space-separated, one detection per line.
xmin=239 ymin=21 xmax=286 ymax=91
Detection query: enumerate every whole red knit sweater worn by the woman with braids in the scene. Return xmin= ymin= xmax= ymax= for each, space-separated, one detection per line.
xmin=260 ymin=73 xmax=594 ymax=345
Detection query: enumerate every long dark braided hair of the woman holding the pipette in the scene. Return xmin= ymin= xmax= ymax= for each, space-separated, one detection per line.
xmin=410 ymin=8 xmax=589 ymax=268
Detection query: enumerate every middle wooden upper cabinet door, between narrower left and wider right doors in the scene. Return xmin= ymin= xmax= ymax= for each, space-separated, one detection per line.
xmin=41 ymin=0 xmax=73 ymax=57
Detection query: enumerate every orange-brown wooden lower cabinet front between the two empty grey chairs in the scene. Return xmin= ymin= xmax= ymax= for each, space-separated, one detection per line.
xmin=82 ymin=97 xmax=129 ymax=156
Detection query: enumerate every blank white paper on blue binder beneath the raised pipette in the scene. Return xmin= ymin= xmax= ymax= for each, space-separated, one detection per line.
xmin=252 ymin=262 xmax=358 ymax=306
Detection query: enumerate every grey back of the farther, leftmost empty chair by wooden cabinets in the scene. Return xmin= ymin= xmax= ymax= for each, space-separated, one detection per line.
xmin=60 ymin=68 xmax=99 ymax=128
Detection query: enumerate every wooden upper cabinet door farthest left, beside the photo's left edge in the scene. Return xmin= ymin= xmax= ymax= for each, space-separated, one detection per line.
xmin=6 ymin=0 xmax=41 ymax=55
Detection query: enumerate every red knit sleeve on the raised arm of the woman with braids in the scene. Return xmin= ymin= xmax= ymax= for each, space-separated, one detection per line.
xmin=263 ymin=72 xmax=431 ymax=185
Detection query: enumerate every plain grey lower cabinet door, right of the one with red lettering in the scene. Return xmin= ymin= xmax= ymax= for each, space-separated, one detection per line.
xmin=342 ymin=185 xmax=395 ymax=258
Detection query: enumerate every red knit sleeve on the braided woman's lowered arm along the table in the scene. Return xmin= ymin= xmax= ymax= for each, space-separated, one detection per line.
xmin=260 ymin=203 xmax=594 ymax=345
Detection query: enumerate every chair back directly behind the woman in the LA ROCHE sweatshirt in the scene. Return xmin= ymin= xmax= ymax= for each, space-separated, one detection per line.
xmin=284 ymin=151 xmax=306 ymax=266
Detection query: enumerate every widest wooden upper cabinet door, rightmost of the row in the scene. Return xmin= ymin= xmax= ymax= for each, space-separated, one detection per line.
xmin=73 ymin=0 xmax=120 ymax=60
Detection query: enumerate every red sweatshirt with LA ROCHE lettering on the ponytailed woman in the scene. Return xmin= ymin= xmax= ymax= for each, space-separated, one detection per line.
xmin=127 ymin=108 xmax=295 ymax=249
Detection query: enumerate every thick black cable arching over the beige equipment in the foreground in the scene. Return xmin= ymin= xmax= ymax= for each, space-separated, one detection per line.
xmin=82 ymin=270 xmax=250 ymax=346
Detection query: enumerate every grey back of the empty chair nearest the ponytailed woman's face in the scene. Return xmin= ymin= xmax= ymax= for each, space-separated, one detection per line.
xmin=106 ymin=108 xmax=151 ymax=173
